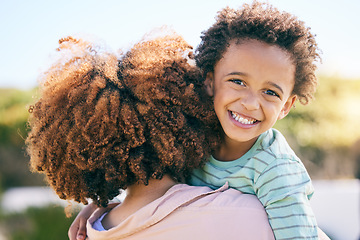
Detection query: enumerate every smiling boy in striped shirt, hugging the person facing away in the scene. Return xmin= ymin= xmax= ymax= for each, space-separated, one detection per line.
xmin=190 ymin=2 xmax=319 ymax=239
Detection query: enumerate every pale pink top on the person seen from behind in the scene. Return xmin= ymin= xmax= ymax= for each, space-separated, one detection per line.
xmin=87 ymin=184 xmax=274 ymax=240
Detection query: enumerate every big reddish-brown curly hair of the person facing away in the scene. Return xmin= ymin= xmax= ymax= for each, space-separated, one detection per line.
xmin=26 ymin=35 xmax=218 ymax=206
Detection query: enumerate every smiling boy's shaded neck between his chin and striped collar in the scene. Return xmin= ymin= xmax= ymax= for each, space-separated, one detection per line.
xmin=214 ymin=136 xmax=257 ymax=162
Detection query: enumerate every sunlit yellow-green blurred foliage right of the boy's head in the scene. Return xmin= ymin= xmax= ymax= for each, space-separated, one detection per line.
xmin=275 ymin=77 xmax=360 ymax=149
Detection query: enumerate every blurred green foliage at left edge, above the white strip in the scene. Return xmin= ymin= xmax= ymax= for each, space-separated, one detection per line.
xmin=0 ymin=89 xmax=44 ymax=191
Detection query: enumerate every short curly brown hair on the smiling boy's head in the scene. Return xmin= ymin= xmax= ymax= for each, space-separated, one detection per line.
xmin=195 ymin=1 xmax=320 ymax=104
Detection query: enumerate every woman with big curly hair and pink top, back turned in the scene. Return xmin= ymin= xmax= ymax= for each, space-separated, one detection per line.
xmin=26 ymin=35 xmax=274 ymax=239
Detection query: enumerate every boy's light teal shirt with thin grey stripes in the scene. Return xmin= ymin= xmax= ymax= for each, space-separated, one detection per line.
xmin=190 ymin=129 xmax=318 ymax=239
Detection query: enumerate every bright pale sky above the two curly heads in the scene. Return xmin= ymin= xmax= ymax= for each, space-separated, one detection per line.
xmin=0 ymin=0 xmax=360 ymax=89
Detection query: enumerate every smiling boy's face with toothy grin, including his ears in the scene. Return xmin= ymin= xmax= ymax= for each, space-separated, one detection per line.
xmin=205 ymin=40 xmax=296 ymax=145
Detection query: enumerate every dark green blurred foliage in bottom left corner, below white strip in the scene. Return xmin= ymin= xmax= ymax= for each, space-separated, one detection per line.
xmin=0 ymin=206 xmax=76 ymax=240
